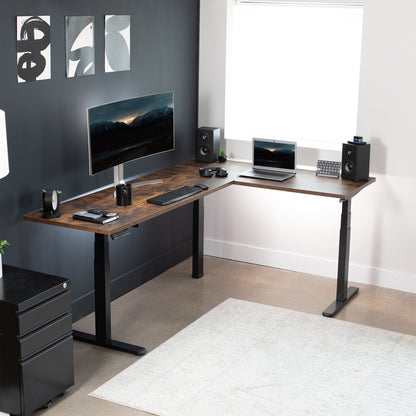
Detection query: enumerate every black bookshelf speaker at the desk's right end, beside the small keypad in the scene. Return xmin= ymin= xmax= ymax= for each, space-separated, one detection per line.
xmin=341 ymin=142 xmax=370 ymax=182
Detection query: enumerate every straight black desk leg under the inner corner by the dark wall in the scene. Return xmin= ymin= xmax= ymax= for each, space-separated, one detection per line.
xmin=192 ymin=198 xmax=204 ymax=279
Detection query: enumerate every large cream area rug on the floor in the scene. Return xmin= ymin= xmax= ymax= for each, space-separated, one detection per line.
xmin=91 ymin=299 xmax=416 ymax=416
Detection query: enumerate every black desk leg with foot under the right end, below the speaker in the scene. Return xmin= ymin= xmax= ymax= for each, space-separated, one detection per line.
xmin=322 ymin=199 xmax=358 ymax=317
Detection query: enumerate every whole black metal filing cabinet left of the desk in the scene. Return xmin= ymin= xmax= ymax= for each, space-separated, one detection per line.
xmin=0 ymin=265 xmax=74 ymax=415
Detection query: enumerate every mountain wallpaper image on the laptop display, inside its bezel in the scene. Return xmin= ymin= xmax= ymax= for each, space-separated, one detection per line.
xmin=254 ymin=141 xmax=295 ymax=169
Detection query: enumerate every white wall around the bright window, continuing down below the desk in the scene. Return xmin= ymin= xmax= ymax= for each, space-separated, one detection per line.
xmin=199 ymin=0 xmax=416 ymax=293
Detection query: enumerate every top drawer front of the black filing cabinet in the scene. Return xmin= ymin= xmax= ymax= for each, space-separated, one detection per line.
xmin=17 ymin=291 xmax=71 ymax=335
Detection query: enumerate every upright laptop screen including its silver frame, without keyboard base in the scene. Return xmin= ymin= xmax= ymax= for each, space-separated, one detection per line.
xmin=253 ymin=139 xmax=296 ymax=172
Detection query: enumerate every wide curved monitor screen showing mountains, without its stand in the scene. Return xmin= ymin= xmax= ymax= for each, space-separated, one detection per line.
xmin=88 ymin=92 xmax=175 ymax=175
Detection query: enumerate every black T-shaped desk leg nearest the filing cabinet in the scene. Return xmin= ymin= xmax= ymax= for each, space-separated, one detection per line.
xmin=73 ymin=233 xmax=146 ymax=355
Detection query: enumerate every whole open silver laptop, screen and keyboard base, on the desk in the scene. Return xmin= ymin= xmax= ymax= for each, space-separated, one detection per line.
xmin=240 ymin=138 xmax=296 ymax=181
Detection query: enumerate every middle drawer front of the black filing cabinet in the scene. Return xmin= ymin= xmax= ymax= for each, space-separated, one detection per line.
xmin=19 ymin=313 xmax=72 ymax=360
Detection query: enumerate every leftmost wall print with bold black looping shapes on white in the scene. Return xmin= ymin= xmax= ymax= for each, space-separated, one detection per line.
xmin=16 ymin=16 xmax=51 ymax=83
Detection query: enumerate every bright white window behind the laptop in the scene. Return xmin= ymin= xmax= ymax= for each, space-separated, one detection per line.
xmin=225 ymin=0 xmax=363 ymax=149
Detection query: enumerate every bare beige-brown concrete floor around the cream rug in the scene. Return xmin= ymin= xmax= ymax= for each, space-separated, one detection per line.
xmin=36 ymin=257 xmax=416 ymax=416
